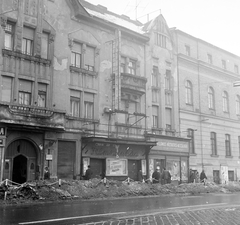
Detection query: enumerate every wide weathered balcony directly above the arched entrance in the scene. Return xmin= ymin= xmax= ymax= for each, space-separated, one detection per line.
xmin=0 ymin=103 xmax=65 ymax=130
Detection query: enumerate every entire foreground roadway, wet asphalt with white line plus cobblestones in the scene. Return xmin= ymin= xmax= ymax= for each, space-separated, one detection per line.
xmin=0 ymin=194 xmax=240 ymax=225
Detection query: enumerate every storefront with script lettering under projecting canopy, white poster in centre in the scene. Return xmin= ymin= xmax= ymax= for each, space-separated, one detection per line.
xmin=82 ymin=137 xmax=156 ymax=181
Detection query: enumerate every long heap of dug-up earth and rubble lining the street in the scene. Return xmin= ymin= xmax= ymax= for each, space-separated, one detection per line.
xmin=0 ymin=179 xmax=240 ymax=204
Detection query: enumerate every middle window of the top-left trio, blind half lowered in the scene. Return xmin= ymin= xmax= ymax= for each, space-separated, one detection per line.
xmin=22 ymin=27 xmax=34 ymax=55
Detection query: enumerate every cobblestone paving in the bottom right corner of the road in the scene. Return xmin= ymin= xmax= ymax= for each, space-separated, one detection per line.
xmin=83 ymin=206 xmax=240 ymax=225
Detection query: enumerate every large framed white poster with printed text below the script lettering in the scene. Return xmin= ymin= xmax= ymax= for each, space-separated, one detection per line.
xmin=106 ymin=158 xmax=128 ymax=176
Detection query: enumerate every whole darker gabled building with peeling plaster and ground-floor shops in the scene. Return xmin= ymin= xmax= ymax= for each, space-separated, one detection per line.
xmin=0 ymin=0 xmax=189 ymax=183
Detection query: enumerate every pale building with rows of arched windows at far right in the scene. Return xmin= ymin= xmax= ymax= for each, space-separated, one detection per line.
xmin=172 ymin=29 xmax=240 ymax=183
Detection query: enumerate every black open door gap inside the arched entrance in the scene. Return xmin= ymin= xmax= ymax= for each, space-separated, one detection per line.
xmin=12 ymin=155 xmax=27 ymax=184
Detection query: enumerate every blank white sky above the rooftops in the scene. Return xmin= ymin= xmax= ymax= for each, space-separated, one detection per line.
xmin=86 ymin=0 xmax=240 ymax=56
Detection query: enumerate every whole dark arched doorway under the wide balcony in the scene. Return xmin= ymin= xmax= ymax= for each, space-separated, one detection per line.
xmin=4 ymin=139 xmax=38 ymax=183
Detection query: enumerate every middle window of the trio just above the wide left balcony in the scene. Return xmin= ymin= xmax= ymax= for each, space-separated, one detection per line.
xmin=18 ymin=80 xmax=32 ymax=105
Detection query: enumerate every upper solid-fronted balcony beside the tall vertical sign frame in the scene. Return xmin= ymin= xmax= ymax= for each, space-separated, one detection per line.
xmin=121 ymin=73 xmax=147 ymax=95
